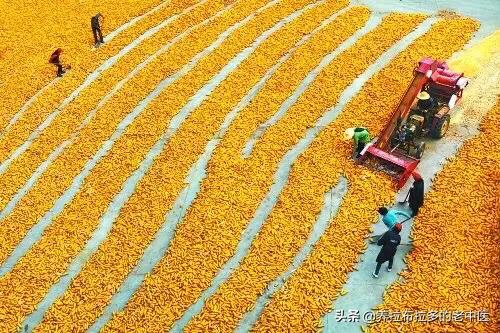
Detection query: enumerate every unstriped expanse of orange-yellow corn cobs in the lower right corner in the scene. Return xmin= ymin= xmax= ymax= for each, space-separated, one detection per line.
xmin=369 ymin=103 xmax=500 ymax=332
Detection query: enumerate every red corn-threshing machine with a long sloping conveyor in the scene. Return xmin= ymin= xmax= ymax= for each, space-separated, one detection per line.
xmin=362 ymin=58 xmax=468 ymax=188
